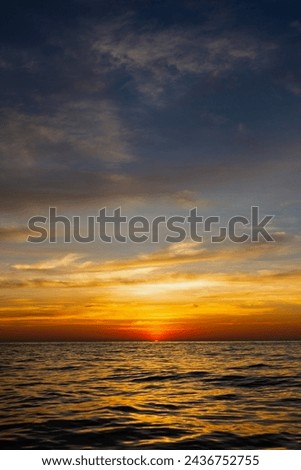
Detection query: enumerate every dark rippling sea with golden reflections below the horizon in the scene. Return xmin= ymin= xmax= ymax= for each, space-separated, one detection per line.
xmin=0 ymin=342 xmax=301 ymax=449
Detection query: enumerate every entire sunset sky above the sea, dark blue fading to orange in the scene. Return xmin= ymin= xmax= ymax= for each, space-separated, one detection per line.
xmin=0 ymin=0 xmax=301 ymax=341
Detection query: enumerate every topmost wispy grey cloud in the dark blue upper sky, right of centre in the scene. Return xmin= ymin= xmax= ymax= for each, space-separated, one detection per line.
xmin=93 ymin=17 xmax=277 ymax=98
